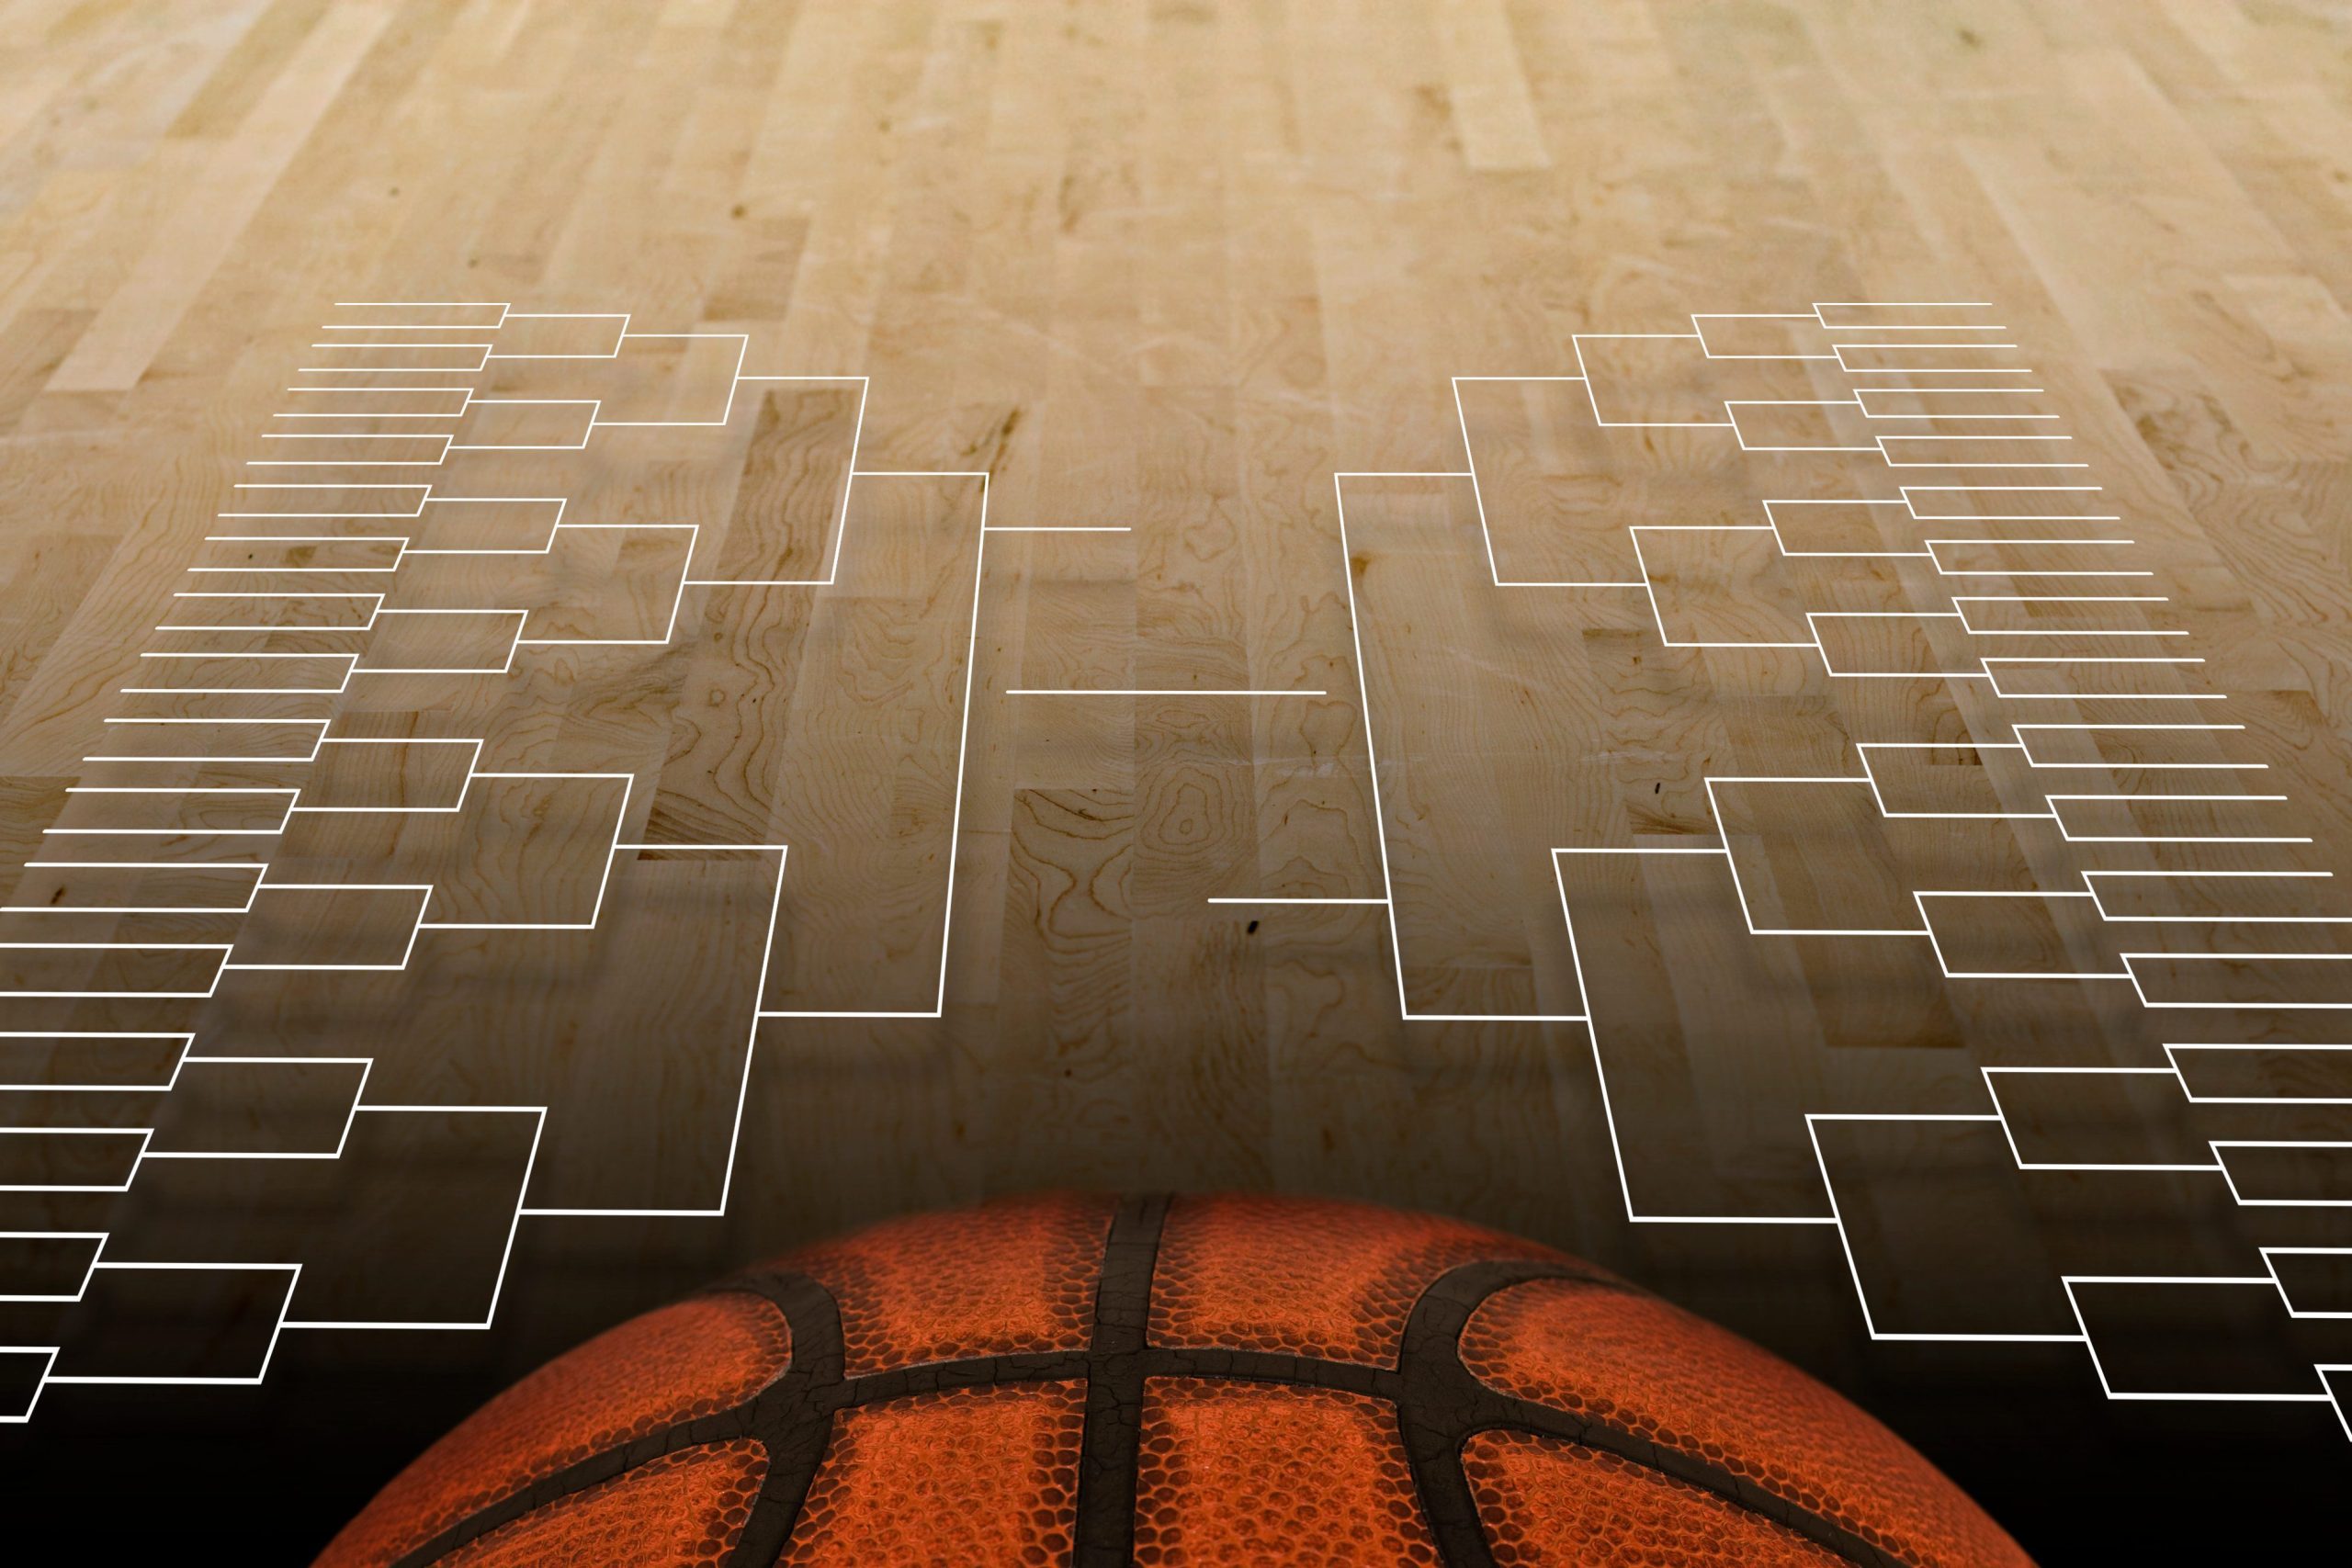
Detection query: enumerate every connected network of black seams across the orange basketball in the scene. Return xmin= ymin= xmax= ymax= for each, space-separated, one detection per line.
xmin=376 ymin=1241 xmax=1907 ymax=1568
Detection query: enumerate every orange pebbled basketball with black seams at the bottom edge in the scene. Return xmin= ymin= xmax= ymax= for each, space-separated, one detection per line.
xmin=320 ymin=1194 xmax=2025 ymax=1568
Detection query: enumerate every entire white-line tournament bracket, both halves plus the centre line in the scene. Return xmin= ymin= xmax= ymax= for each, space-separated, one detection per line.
xmin=0 ymin=301 xmax=2352 ymax=1448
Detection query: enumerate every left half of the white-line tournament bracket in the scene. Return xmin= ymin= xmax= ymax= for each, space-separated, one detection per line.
xmin=0 ymin=301 xmax=988 ymax=1420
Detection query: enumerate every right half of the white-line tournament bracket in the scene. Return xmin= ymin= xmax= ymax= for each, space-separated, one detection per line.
xmin=1339 ymin=301 xmax=2352 ymax=1417
